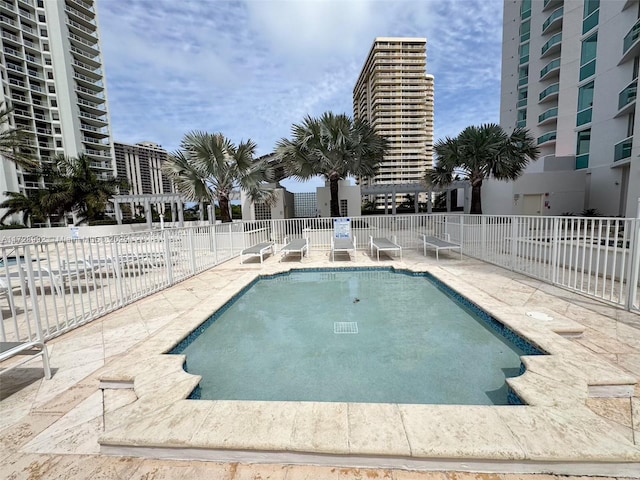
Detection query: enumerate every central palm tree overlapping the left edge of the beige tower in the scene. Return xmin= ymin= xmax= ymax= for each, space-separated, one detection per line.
xmin=276 ymin=112 xmax=387 ymax=217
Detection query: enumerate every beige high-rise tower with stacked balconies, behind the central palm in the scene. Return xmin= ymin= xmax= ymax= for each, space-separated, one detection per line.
xmin=353 ymin=37 xmax=434 ymax=202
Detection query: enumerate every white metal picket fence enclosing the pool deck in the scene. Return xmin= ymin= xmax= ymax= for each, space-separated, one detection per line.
xmin=0 ymin=214 xmax=640 ymax=341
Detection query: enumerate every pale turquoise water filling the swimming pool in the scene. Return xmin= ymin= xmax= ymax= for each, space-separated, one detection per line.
xmin=172 ymin=270 xmax=540 ymax=405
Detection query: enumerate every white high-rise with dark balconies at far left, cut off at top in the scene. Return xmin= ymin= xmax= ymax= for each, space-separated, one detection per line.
xmin=0 ymin=0 xmax=115 ymax=224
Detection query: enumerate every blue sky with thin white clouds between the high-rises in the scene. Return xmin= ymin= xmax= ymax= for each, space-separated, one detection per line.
xmin=98 ymin=0 xmax=502 ymax=192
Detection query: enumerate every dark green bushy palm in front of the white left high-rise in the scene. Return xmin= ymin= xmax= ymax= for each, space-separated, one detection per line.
xmin=52 ymin=154 xmax=126 ymax=224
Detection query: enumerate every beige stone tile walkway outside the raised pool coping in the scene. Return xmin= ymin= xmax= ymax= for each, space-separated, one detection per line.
xmin=0 ymin=252 xmax=640 ymax=480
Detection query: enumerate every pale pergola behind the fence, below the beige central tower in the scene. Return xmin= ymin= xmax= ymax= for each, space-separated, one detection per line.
xmin=360 ymin=180 xmax=471 ymax=215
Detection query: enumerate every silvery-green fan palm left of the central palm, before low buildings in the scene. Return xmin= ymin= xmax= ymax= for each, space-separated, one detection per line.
xmin=162 ymin=131 xmax=275 ymax=222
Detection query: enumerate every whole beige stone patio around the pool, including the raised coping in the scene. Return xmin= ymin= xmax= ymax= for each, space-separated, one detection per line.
xmin=0 ymin=248 xmax=640 ymax=479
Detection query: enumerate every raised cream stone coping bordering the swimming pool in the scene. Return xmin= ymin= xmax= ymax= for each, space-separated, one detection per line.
xmin=99 ymin=262 xmax=640 ymax=476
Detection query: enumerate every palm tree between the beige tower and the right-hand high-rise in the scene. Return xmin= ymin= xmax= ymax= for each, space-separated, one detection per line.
xmin=426 ymin=123 xmax=540 ymax=214
